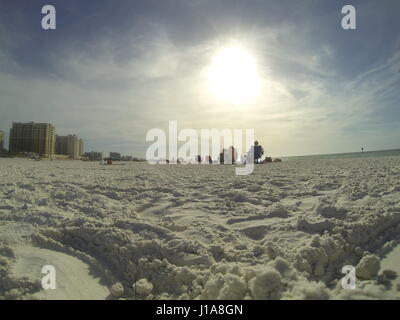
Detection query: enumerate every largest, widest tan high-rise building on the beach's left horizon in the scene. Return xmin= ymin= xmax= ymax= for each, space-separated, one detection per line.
xmin=9 ymin=122 xmax=56 ymax=158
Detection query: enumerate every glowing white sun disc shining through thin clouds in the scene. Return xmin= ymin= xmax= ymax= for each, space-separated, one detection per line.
xmin=208 ymin=46 xmax=261 ymax=103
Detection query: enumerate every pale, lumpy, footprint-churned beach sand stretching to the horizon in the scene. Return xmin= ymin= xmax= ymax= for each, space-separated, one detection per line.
xmin=0 ymin=157 xmax=400 ymax=299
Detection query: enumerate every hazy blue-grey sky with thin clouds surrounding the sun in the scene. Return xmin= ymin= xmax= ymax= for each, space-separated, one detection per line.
xmin=0 ymin=0 xmax=400 ymax=157
